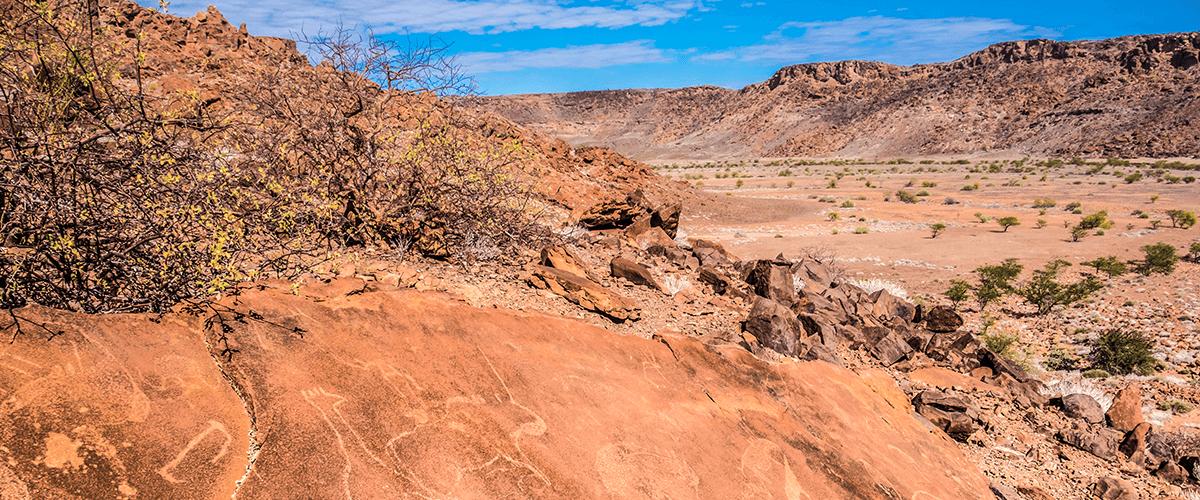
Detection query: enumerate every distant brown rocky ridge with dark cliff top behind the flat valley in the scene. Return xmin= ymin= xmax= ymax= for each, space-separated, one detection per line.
xmin=478 ymin=32 xmax=1200 ymax=159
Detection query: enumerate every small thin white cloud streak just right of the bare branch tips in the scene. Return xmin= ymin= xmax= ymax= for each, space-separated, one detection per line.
xmin=455 ymin=40 xmax=673 ymax=74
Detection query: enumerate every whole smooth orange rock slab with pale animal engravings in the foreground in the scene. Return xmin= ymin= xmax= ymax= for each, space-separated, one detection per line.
xmin=0 ymin=285 xmax=989 ymax=499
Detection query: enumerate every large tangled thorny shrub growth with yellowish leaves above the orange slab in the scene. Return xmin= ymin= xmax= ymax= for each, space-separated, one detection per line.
xmin=0 ymin=1 xmax=540 ymax=312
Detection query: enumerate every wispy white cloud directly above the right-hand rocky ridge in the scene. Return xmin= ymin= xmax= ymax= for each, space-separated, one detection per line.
xmin=692 ymin=16 xmax=1060 ymax=65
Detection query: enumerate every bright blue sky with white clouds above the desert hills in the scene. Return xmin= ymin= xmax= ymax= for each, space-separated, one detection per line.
xmin=150 ymin=0 xmax=1200 ymax=95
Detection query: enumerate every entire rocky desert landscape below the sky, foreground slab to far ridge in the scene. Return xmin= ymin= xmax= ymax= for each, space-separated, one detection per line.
xmin=0 ymin=0 xmax=1200 ymax=500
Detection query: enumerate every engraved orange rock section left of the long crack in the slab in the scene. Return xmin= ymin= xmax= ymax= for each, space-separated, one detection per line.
xmin=0 ymin=311 xmax=250 ymax=499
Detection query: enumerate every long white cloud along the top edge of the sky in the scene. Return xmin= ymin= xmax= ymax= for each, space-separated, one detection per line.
xmin=159 ymin=0 xmax=704 ymax=36
